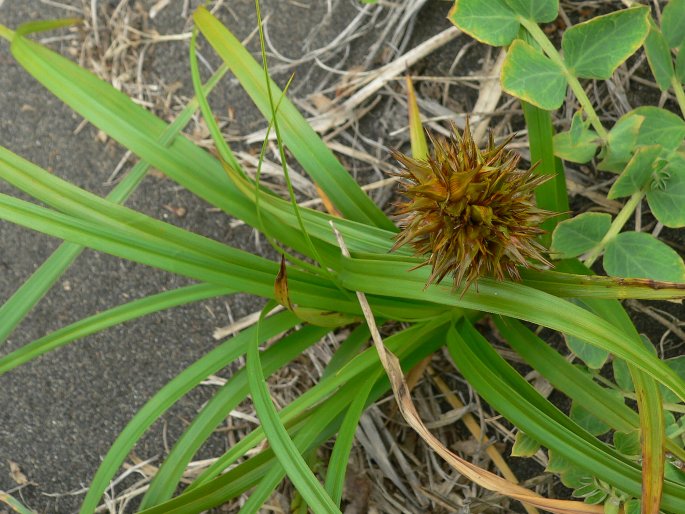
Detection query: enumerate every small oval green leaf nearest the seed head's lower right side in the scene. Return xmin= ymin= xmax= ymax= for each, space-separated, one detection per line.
xmin=550 ymin=212 xmax=611 ymax=259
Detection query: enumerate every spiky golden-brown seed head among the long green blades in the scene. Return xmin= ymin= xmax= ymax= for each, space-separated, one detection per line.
xmin=393 ymin=120 xmax=553 ymax=291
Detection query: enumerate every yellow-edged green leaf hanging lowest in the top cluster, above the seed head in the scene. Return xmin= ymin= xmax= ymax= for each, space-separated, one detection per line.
xmin=500 ymin=39 xmax=566 ymax=111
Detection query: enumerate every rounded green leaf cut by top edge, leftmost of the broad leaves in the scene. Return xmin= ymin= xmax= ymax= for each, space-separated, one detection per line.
xmin=448 ymin=0 xmax=520 ymax=46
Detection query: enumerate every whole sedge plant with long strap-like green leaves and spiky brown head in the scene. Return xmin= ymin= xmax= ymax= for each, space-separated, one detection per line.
xmin=0 ymin=0 xmax=685 ymax=514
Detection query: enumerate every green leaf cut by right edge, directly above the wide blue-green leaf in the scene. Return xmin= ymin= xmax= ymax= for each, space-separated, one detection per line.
xmin=647 ymin=153 xmax=685 ymax=228
